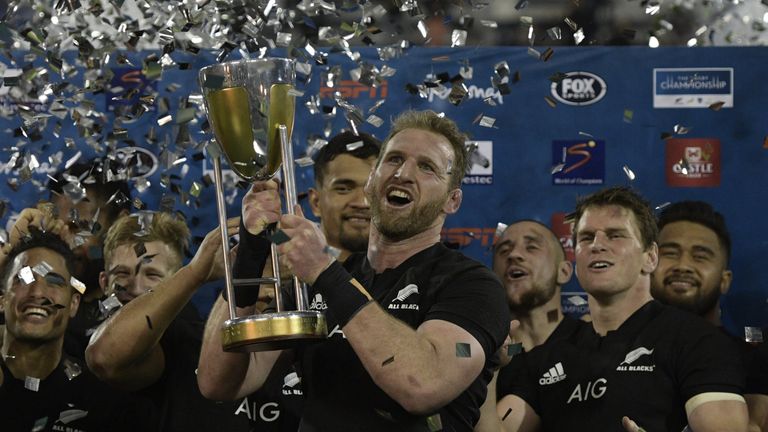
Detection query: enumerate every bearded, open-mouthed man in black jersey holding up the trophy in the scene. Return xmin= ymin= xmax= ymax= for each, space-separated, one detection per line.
xmin=198 ymin=111 xmax=509 ymax=431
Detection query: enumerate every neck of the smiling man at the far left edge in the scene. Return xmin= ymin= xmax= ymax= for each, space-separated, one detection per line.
xmin=2 ymin=332 xmax=64 ymax=380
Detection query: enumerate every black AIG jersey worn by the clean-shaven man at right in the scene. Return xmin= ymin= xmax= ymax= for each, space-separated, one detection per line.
xmin=499 ymin=301 xmax=744 ymax=432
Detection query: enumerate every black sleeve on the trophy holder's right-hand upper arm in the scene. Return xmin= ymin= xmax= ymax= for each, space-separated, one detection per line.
xmin=426 ymin=266 xmax=511 ymax=359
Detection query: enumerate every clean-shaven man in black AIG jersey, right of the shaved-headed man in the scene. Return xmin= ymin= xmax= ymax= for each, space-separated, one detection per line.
xmin=498 ymin=187 xmax=747 ymax=432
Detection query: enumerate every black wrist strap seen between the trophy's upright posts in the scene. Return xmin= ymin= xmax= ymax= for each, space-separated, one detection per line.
xmin=221 ymin=218 xmax=270 ymax=307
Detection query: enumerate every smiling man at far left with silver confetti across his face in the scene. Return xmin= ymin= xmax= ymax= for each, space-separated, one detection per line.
xmin=0 ymin=230 xmax=143 ymax=432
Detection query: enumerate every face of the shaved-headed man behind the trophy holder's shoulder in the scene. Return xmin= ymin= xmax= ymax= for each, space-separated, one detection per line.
xmin=493 ymin=221 xmax=571 ymax=312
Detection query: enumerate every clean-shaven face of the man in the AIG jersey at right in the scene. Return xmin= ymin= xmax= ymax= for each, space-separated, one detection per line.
xmin=574 ymin=205 xmax=658 ymax=299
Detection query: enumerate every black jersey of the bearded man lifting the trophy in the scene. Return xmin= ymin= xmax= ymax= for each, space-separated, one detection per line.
xmin=300 ymin=243 xmax=510 ymax=432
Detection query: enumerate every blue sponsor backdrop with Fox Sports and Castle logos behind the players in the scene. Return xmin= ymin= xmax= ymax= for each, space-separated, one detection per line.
xmin=0 ymin=47 xmax=768 ymax=335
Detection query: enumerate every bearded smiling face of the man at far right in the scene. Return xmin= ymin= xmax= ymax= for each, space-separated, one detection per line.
xmin=651 ymin=221 xmax=731 ymax=315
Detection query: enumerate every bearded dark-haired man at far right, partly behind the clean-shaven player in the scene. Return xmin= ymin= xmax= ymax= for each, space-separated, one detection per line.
xmin=651 ymin=201 xmax=768 ymax=430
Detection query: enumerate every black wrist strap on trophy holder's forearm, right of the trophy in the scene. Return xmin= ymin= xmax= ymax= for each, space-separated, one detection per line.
xmin=312 ymin=261 xmax=373 ymax=328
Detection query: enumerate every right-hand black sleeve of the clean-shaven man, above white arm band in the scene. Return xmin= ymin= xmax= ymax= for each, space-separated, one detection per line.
xmin=676 ymin=317 xmax=744 ymax=401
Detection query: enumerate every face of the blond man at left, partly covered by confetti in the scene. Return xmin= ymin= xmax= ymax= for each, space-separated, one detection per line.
xmin=99 ymin=241 xmax=181 ymax=304
